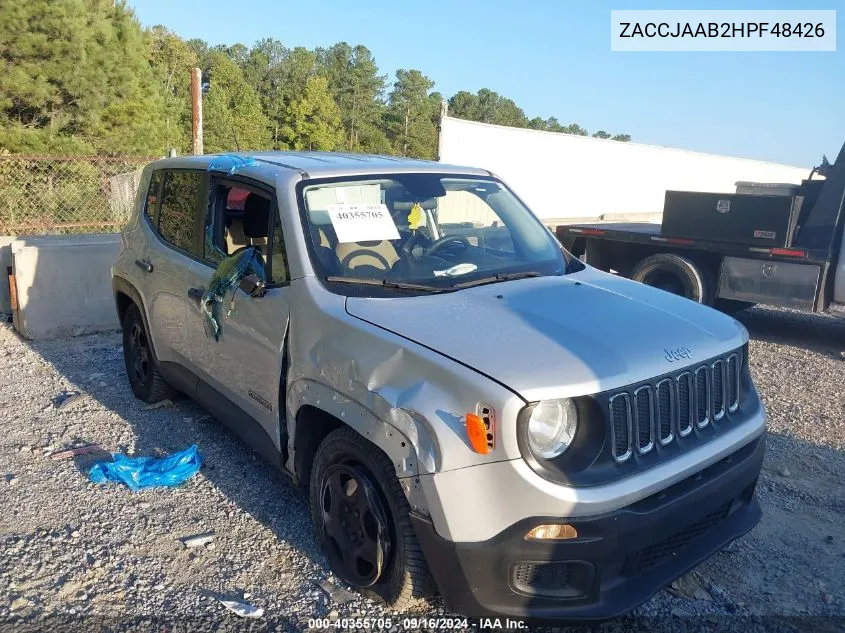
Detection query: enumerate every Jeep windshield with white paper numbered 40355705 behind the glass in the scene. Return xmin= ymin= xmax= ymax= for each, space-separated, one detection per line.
xmin=302 ymin=174 xmax=567 ymax=291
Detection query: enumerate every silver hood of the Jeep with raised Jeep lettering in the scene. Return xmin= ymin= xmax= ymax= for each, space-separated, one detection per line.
xmin=346 ymin=267 xmax=748 ymax=402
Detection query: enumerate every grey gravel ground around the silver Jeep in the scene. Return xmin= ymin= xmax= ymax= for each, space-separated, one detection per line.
xmin=0 ymin=309 xmax=845 ymax=633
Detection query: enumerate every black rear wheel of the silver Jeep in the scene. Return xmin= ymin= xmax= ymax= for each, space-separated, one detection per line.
xmin=123 ymin=303 xmax=176 ymax=403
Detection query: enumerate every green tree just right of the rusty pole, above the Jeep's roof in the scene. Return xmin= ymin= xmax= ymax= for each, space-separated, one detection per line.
xmin=203 ymin=51 xmax=270 ymax=153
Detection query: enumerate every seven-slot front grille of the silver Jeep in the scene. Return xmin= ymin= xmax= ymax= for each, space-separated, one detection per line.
xmin=609 ymin=352 xmax=742 ymax=463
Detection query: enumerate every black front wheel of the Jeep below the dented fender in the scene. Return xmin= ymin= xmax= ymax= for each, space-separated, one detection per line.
xmin=310 ymin=426 xmax=434 ymax=610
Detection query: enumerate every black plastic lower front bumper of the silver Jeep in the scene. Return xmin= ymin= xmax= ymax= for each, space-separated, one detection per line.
xmin=412 ymin=436 xmax=765 ymax=620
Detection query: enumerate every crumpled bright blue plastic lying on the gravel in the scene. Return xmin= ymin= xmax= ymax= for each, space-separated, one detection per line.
xmin=88 ymin=444 xmax=202 ymax=491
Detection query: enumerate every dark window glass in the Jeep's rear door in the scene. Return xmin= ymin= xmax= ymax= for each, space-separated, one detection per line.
xmin=158 ymin=171 xmax=203 ymax=253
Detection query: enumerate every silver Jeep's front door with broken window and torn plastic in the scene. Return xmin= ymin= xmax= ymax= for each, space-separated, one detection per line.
xmin=187 ymin=179 xmax=290 ymax=452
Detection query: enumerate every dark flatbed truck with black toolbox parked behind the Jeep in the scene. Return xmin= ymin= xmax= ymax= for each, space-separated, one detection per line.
xmin=555 ymin=145 xmax=845 ymax=316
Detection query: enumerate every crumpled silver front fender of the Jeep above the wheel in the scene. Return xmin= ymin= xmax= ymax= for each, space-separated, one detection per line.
xmin=286 ymin=276 xmax=526 ymax=476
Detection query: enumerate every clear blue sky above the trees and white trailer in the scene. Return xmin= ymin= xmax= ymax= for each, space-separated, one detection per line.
xmin=129 ymin=0 xmax=845 ymax=166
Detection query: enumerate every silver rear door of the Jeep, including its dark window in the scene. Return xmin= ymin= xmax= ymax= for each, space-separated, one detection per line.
xmin=139 ymin=169 xmax=208 ymax=365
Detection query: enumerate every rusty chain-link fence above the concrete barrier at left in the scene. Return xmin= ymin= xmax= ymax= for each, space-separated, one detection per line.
xmin=0 ymin=154 xmax=154 ymax=235
